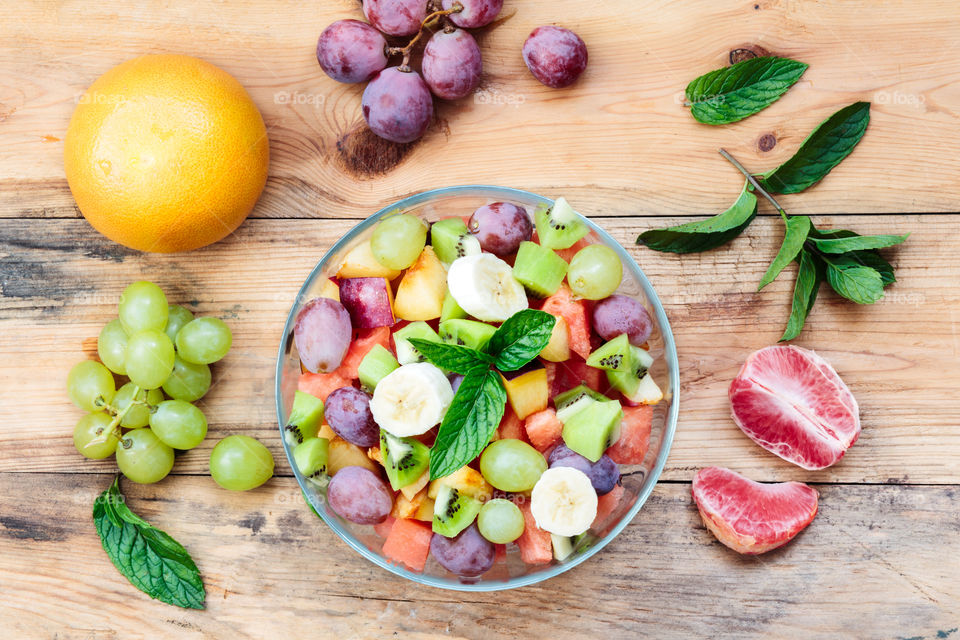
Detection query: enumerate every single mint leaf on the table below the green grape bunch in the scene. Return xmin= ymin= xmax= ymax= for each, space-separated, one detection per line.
xmin=93 ymin=476 xmax=206 ymax=609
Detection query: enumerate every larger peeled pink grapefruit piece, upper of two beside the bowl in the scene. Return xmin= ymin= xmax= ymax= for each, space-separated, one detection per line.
xmin=729 ymin=346 xmax=860 ymax=469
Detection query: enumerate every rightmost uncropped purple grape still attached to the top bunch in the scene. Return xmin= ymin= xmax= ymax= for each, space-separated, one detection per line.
xmin=420 ymin=27 xmax=483 ymax=100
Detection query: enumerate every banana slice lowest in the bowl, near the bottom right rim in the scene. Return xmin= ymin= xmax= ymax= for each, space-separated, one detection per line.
xmin=530 ymin=467 xmax=597 ymax=536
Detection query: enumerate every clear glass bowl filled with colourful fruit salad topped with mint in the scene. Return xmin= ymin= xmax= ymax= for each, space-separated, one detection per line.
xmin=276 ymin=186 xmax=678 ymax=591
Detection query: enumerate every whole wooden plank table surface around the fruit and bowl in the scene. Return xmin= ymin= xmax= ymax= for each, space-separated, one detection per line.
xmin=0 ymin=0 xmax=960 ymax=639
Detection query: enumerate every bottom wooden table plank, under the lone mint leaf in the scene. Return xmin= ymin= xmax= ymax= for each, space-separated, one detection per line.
xmin=0 ymin=473 xmax=960 ymax=638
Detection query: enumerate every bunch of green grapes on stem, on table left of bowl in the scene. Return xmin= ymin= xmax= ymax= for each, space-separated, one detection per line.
xmin=67 ymin=282 xmax=260 ymax=483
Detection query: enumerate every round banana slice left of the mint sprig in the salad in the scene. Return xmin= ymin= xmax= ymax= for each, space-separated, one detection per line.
xmin=370 ymin=362 xmax=453 ymax=438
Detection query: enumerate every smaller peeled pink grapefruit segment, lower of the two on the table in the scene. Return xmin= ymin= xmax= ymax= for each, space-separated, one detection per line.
xmin=692 ymin=467 xmax=817 ymax=555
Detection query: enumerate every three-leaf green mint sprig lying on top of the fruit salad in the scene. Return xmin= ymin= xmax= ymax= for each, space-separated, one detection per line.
xmin=410 ymin=309 xmax=557 ymax=480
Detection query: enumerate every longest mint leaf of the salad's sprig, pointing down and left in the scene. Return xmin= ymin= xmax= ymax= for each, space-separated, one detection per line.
xmin=430 ymin=369 xmax=507 ymax=480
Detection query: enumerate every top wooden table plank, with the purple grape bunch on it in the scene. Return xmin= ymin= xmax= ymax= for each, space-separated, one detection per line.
xmin=0 ymin=0 xmax=960 ymax=218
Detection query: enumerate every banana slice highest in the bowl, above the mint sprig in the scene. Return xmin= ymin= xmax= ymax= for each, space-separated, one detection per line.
xmin=447 ymin=253 xmax=527 ymax=322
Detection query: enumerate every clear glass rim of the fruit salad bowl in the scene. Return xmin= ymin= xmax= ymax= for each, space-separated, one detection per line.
xmin=274 ymin=184 xmax=680 ymax=592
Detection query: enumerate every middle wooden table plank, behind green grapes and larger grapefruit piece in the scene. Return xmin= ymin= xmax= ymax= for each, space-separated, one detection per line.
xmin=0 ymin=215 xmax=960 ymax=483
